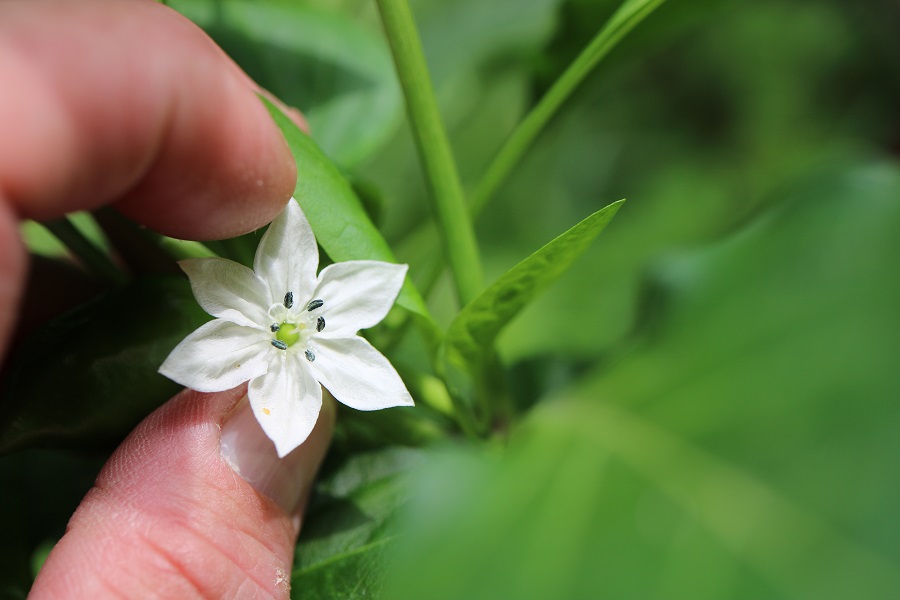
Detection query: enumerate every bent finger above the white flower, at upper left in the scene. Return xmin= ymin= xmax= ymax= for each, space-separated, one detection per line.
xmin=0 ymin=0 xmax=296 ymax=239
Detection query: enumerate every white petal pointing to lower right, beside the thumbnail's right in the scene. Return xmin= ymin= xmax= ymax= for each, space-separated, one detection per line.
xmin=309 ymin=336 xmax=413 ymax=410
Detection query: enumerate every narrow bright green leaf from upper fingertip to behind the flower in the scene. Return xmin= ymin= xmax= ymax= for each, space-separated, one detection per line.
xmin=262 ymin=98 xmax=431 ymax=338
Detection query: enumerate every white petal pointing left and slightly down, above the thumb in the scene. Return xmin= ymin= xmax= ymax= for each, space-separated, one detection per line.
xmin=159 ymin=319 xmax=273 ymax=392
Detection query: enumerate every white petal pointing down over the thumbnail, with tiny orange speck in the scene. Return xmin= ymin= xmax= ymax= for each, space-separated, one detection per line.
xmin=247 ymin=352 xmax=322 ymax=458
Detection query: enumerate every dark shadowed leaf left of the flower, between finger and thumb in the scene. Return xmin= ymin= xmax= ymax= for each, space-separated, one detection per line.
xmin=0 ymin=277 xmax=209 ymax=452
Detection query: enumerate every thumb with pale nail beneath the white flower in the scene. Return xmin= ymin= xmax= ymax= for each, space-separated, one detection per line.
xmin=30 ymin=386 xmax=334 ymax=598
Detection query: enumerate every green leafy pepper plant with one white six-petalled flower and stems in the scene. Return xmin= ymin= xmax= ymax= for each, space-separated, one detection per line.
xmin=0 ymin=0 xmax=900 ymax=599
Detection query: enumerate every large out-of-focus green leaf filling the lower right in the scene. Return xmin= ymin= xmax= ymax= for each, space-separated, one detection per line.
xmin=389 ymin=165 xmax=900 ymax=600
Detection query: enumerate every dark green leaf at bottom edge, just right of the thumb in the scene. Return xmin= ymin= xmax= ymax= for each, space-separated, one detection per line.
xmin=291 ymin=448 xmax=421 ymax=600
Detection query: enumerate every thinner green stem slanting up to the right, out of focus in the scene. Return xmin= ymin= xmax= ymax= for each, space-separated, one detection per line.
xmin=471 ymin=0 xmax=665 ymax=215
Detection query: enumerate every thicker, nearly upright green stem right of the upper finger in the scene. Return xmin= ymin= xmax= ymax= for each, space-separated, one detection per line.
xmin=378 ymin=0 xmax=482 ymax=306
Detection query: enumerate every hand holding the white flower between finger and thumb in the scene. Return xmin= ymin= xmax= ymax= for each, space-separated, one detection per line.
xmin=0 ymin=0 xmax=333 ymax=598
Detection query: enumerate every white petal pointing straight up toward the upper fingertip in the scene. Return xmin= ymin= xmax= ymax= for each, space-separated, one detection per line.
xmin=253 ymin=198 xmax=319 ymax=305
